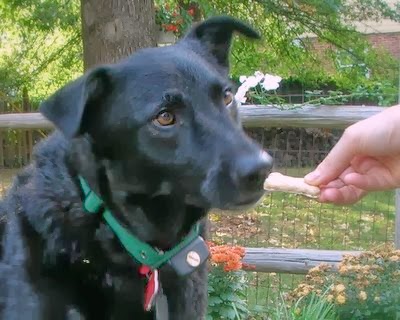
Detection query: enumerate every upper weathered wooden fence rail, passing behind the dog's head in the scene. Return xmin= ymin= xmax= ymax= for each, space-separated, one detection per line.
xmin=0 ymin=105 xmax=383 ymax=129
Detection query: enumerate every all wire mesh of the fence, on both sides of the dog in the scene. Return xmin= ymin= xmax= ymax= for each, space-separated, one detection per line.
xmin=0 ymin=128 xmax=395 ymax=312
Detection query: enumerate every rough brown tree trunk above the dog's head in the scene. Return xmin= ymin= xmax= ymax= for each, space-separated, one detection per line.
xmin=81 ymin=0 xmax=156 ymax=70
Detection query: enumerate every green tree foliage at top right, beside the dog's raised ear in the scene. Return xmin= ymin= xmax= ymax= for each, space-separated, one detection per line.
xmin=191 ymin=0 xmax=400 ymax=90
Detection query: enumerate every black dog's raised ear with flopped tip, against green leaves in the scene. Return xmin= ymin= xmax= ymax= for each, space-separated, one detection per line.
xmin=182 ymin=16 xmax=261 ymax=71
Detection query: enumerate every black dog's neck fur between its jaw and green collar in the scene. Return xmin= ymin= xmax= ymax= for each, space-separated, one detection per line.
xmin=65 ymin=138 xmax=207 ymax=249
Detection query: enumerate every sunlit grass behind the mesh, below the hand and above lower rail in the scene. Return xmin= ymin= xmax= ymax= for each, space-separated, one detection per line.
xmin=212 ymin=169 xmax=395 ymax=250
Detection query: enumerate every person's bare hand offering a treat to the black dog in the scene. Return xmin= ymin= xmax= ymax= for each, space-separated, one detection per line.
xmin=305 ymin=105 xmax=400 ymax=204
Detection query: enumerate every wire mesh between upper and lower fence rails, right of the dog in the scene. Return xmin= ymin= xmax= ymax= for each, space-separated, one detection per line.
xmin=212 ymin=128 xmax=395 ymax=250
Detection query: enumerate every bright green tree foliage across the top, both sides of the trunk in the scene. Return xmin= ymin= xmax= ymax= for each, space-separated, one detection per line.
xmin=0 ymin=0 xmax=400 ymax=107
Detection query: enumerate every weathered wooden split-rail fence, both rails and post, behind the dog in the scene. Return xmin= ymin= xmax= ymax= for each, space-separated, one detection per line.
xmin=0 ymin=105 xmax=400 ymax=274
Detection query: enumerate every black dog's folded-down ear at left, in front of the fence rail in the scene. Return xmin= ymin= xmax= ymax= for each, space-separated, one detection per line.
xmin=39 ymin=67 xmax=113 ymax=138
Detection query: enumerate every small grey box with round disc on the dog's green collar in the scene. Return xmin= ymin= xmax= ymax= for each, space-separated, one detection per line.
xmin=168 ymin=236 xmax=210 ymax=277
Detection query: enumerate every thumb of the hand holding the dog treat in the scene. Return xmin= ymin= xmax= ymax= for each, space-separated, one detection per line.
xmin=304 ymin=130 xmax=358 ymax=186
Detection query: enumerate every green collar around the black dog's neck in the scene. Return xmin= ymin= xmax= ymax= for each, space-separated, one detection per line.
xmin=79 ymin=177 xmax=200 ymax=270
